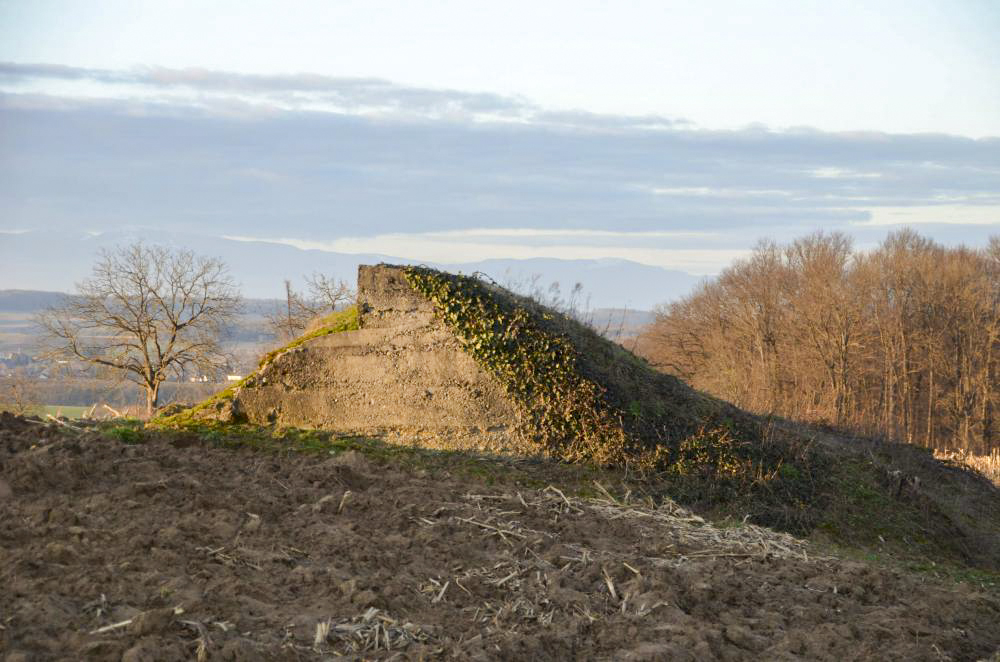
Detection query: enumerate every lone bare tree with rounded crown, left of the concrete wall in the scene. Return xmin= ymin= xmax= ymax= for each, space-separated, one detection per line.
xmin=38 ymin=243 xmax=240 ymax=415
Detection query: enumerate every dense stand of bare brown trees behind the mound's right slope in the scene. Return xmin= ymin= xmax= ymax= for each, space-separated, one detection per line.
xmin=638 ymin=229 xmax=1000 ymax=454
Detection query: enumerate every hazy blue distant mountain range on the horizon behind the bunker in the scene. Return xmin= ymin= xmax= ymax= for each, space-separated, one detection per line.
xmin=0 ymin=230 xmax=700 ymax=310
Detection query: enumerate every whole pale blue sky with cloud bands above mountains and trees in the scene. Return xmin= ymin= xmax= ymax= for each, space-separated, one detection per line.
xmin=0 ymin=0 xmax=1000 ymax=287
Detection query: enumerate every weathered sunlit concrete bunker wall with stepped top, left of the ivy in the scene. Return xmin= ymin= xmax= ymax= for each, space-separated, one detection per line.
xmin=232 ymin=265 xmax=517 ymax=450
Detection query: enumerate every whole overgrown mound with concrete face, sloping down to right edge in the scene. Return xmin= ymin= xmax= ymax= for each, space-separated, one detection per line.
xmin=160 ymin=265 xmax=1000 ymax=568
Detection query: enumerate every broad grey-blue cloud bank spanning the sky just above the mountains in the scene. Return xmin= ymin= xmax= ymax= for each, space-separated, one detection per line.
xmin=0 ymin=64 xmax=1000 ymax=266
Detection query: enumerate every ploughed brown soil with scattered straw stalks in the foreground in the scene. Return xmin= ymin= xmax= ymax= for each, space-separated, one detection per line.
xmin=0 ymin=416 xmax=1000 ymax=661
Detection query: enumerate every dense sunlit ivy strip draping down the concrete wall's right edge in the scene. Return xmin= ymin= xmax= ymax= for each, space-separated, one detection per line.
xmin=404 ymin=267 xmax=626 ymax=464
